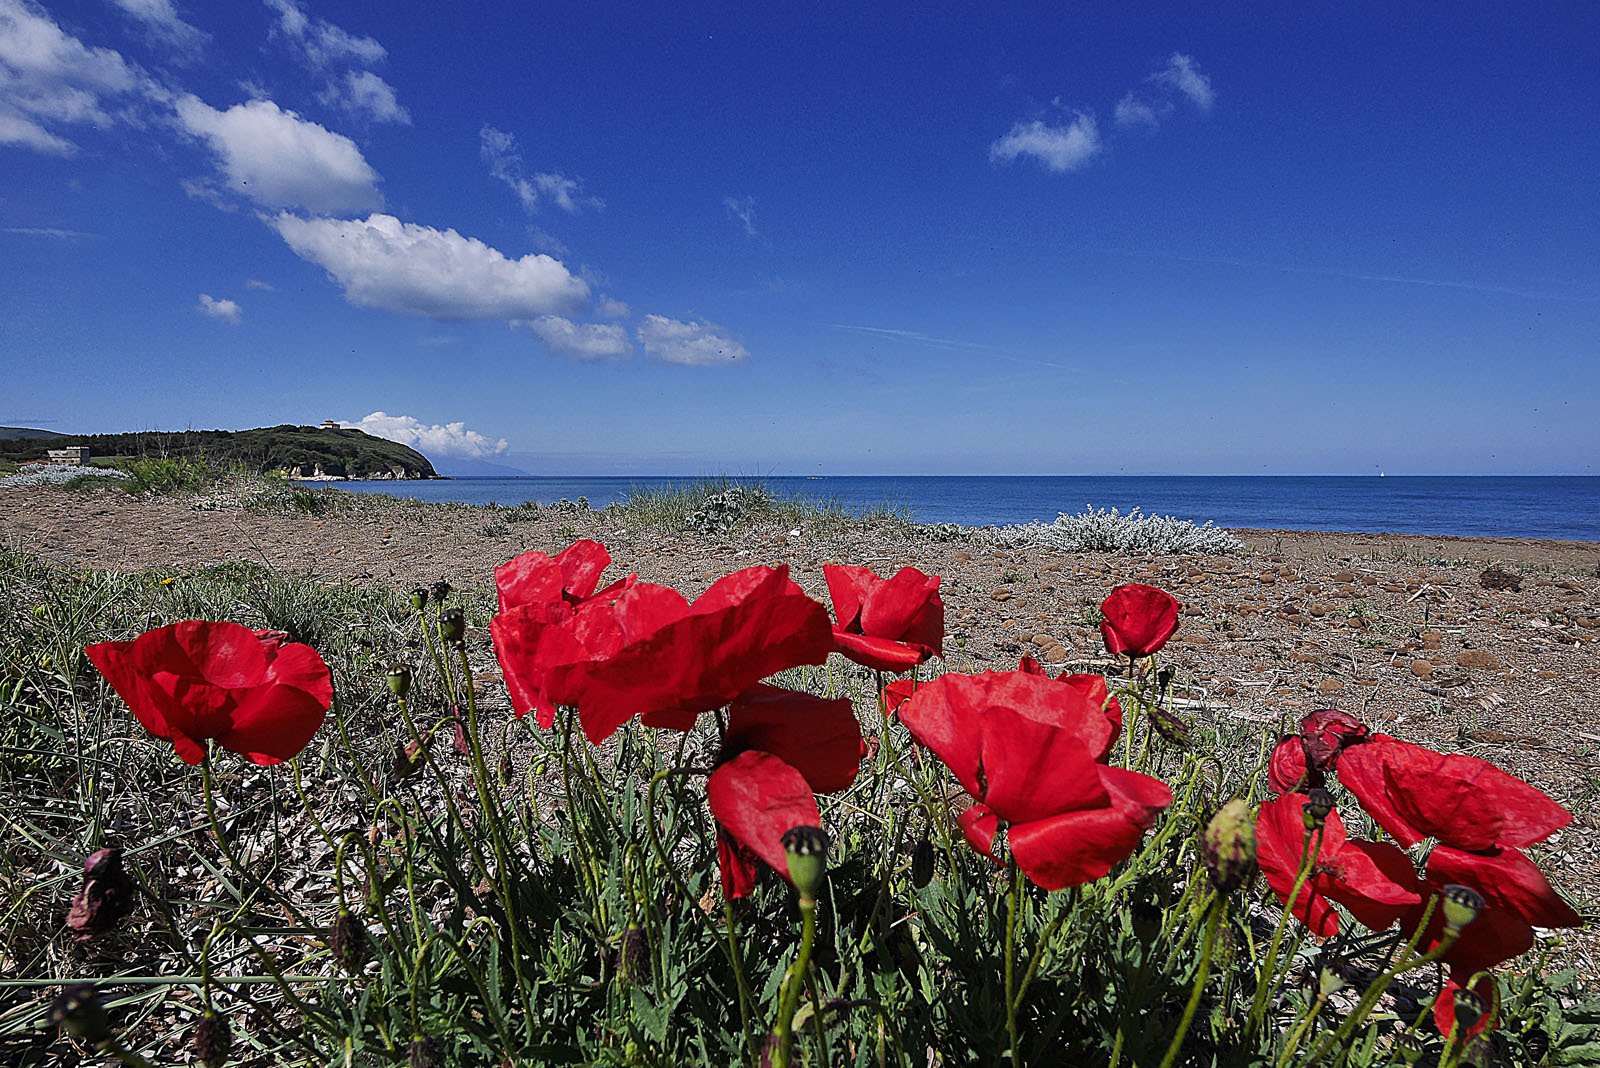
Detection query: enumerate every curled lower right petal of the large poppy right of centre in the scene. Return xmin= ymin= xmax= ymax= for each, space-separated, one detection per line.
xmin=1008 ymin=766 xmax=1173 ymax=891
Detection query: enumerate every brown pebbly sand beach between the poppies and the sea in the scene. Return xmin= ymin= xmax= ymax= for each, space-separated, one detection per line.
xmin=0 ymin=488 xmax=1600 ymax=975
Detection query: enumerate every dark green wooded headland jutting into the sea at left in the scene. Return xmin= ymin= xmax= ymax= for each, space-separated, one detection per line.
xmin=0 ymin=424 xmax=440 ymax=478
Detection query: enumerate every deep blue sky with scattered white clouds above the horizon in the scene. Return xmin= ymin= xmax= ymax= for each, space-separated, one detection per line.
xmin=0 ymin=0 xmax=1600 ymax=475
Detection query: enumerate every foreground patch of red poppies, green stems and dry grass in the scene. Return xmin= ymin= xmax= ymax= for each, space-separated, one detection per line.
xmin=0 ymin=511 xmax=1600 ymax=1068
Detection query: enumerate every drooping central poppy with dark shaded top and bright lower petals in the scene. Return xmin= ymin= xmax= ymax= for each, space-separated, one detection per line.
xmin=706 ymin=686 xmax=861 ymax=899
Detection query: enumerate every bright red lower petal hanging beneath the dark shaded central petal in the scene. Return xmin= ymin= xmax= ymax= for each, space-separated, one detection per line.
xmin=706 ymin=751 xmax=822 ymax=892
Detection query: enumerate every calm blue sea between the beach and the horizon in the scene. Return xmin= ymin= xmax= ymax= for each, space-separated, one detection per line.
xmin=334 ymin=475 xmax=1600 ymax=540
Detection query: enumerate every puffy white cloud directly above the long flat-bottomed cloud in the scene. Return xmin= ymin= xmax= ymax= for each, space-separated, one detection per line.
xmin=178 ymin=96 xmax=382 ymax=213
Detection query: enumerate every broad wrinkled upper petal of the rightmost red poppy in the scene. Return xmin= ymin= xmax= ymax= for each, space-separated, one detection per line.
xmin=1339 ymin=734 xmax=1573 ymax=852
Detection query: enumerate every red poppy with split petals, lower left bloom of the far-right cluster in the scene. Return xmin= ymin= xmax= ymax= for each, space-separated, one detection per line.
xmin=1256 ymin=793 xmax=1422 ymax=938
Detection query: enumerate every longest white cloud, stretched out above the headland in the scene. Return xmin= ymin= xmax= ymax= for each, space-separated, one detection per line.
xmin=267 ymin=213 xmax=589 ymax=320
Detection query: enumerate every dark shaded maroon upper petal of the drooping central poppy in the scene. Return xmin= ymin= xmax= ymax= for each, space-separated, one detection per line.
xmin=723 ymin=684 xmax=861 ymax=793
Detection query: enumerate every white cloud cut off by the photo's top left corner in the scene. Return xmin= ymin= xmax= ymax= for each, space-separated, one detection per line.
xmin=0 ymin=0 xmax=155 ymax=155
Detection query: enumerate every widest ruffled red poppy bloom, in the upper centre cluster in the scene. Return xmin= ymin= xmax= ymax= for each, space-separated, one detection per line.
xmin=546 ymin=566 xmax=834 ymax=741
